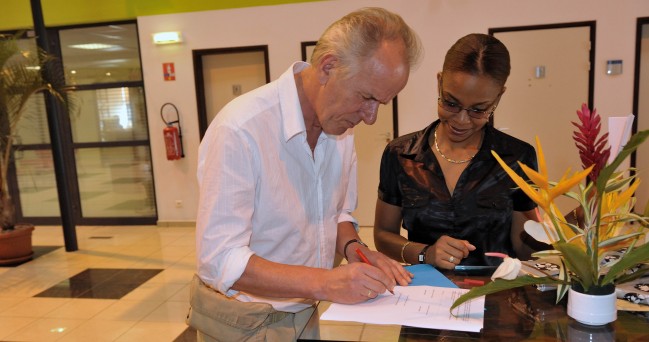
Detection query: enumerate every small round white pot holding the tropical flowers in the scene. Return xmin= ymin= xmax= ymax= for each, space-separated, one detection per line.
xmin=568 ymin=288 xmax=617 ymax=325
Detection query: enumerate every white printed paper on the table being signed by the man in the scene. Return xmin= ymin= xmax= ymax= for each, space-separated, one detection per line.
xmin=320 ymin=286 xmax=485 ymax=332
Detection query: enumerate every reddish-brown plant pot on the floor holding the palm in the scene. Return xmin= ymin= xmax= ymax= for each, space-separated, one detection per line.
xmin=0 ymin=224 xmax=34 ymax=265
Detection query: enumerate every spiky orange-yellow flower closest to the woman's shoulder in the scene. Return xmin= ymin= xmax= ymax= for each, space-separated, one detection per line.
xmin=491 ymin=136 xmax=593 ymax=212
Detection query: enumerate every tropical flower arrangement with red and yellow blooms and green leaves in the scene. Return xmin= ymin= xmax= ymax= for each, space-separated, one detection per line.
xmin=451 ymin=104 xmax=649 ymax=310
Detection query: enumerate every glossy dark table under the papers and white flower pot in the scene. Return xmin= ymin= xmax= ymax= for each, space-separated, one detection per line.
xmin=299 ymin=272 xmax=649 ymax=342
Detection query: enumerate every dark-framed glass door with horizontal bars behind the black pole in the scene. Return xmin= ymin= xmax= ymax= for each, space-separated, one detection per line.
xmin=16 ymin=22 xmax=157 ymax=225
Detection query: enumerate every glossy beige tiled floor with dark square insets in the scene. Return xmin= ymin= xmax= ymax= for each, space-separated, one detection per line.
xmin=0 ymin=226 xmax=374 ymax=342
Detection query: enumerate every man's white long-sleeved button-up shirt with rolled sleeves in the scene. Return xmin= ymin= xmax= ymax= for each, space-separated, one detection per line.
xmin=196 ymin=62 xmax=357 ymax=312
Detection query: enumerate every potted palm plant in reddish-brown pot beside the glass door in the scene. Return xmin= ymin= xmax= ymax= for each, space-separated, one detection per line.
xmin=0 ymin=34 xmax=64 ymax=265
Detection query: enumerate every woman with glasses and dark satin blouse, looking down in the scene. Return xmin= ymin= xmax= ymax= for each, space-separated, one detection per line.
xmin=374 ymin=34 xmax=537 ymax=269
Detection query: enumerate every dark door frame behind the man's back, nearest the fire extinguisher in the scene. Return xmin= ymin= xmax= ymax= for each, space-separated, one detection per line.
xmin=192 ymin=45 xmax=270 ymax=140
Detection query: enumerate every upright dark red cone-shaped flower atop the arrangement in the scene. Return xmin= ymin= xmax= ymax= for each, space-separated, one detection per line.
xmin=571 ymin=103 xmax=611 ymax=182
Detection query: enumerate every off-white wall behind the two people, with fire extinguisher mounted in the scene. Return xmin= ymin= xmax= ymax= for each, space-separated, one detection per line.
xmin=138 ymin=0 xmax=649 ymax=222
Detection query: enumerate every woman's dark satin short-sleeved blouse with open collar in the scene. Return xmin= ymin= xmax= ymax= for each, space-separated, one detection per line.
xmin=378 ymin=120 xmax=537 ymax=265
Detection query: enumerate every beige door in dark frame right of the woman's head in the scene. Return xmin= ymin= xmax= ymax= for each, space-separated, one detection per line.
xmin=489 ymin=21 xmax=595 ymax=210
